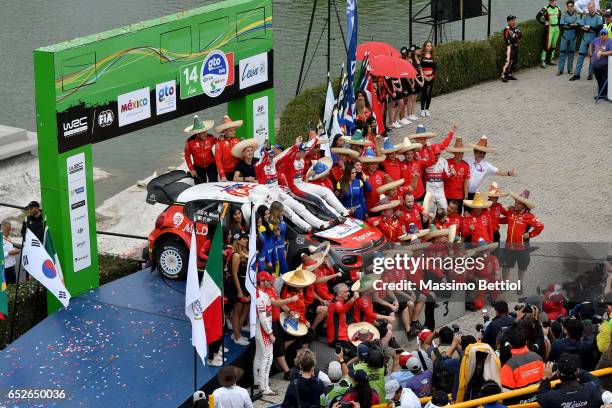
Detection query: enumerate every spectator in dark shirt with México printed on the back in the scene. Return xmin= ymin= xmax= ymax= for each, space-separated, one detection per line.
xmin=537 ymin=353 xmax=602 ymax=408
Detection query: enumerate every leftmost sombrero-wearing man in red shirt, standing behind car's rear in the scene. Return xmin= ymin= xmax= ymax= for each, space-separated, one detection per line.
xmin=185 ymin=115 xmax=217 ymax=184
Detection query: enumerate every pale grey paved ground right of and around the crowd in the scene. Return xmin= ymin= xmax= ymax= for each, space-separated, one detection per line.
xmin=255 ymin=67 xmax=612 ymax=407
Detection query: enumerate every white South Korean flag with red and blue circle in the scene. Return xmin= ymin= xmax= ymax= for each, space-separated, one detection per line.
xmin=21 ymin=228 xmax=70 ymax=307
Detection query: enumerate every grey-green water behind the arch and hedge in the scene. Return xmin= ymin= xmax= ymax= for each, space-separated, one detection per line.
xmin=0 ymin=0 xmax=545 ymax=203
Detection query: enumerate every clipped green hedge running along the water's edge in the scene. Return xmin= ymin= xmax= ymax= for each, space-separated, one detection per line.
xmin=277 ymin=20 xmax=548 ymax=146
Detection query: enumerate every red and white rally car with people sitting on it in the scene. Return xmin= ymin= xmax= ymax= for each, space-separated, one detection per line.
xmin=147 ymin=170 xmax=388 ymax=280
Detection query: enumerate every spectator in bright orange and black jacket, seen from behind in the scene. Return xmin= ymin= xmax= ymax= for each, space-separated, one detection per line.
xmin=501 ymin=329 xmax=544 ymax=389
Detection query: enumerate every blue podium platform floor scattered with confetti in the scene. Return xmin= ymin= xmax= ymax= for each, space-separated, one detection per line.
xmin=0 ymin=270 xmax=250 ymax=408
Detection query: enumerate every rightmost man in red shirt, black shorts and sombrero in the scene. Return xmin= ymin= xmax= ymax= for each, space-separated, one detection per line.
xmin=499 ymin=190 xmax=544 ymax=295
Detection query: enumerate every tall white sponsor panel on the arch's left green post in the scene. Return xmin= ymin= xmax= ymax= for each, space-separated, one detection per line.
xmin=66 ymin=153 xmax=91 ymax=272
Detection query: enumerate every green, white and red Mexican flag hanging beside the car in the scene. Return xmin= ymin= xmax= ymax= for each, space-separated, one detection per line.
xmin=200 ymin=223 xmax=223 ymax=344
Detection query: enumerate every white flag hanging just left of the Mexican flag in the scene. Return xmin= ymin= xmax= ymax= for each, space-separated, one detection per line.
xmin=185 ymin=228 xmax=208 ymax=365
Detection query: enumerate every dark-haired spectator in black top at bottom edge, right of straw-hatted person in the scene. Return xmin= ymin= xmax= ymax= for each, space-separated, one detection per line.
xmin=282 ymin=354 xmax=324 ymax=408
